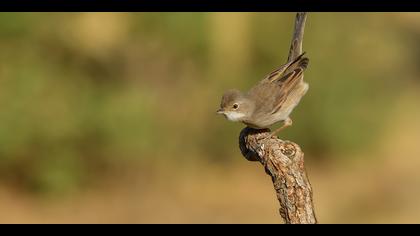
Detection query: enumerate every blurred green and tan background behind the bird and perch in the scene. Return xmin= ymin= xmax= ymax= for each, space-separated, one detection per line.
xmin=0 ymin=13 xmax=420 ymax=223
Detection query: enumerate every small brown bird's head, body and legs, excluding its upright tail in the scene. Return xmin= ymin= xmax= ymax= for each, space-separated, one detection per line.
xmin=217 ymin=53 xmax=309 ymax=137
